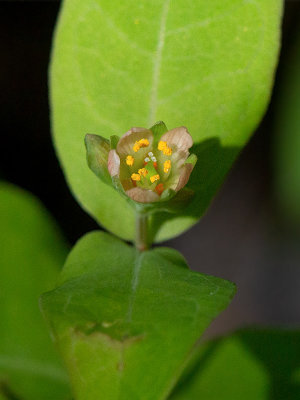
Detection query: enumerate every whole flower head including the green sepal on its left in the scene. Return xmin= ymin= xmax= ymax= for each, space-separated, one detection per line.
xmin=85 ymin=121 xmax=197 ymax=208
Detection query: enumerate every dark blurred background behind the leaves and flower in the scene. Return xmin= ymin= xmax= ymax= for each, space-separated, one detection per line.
xmin=0 ymin=0 xmax=300 ymax=334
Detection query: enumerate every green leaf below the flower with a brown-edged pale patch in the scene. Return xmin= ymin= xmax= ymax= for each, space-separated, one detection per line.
xmin=41 ymin=232 xmax=235 ymax=400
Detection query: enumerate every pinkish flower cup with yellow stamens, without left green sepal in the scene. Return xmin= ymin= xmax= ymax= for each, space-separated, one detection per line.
xmin=107 ymin=123 xmax=197 ymax=203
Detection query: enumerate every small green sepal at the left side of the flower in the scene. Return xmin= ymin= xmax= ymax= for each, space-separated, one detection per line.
xmin=85 ymin=134 xmax=111 ymax=185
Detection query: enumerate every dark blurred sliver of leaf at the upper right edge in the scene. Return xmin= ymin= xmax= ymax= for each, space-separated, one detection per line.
xmin=274 ymin=33 xmax=300 ymax=226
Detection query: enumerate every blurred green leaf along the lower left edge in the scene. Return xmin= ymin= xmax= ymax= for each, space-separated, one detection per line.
xmin=0 ymin=182 xmax=68 ymax=400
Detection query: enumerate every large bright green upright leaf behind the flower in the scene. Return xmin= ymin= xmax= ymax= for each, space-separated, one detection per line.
xmin=50 ymin=0 xmax=282 ymax=240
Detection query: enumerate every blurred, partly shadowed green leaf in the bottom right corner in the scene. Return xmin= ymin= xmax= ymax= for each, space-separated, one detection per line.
xmin=170 ymin=329 xmax=300 ymax=400
